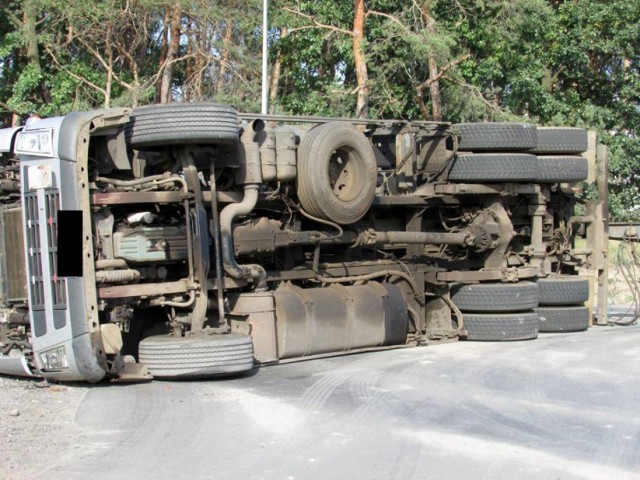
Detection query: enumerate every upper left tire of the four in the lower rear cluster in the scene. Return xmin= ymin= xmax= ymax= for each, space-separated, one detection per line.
xmin=451 ymin=282 xmax=538 ymax=312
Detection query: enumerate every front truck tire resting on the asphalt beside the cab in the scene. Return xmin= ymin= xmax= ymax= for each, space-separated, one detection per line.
xmin=139 ymin=334 xmax=253 ymax=379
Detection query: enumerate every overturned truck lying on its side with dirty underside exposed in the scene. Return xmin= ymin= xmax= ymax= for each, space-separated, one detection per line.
xmin=0 ymin=104 xmax=605 ymax=382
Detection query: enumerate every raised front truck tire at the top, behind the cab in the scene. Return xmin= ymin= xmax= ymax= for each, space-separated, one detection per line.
xmin=127 ymin=103 xmax=238 ymax=150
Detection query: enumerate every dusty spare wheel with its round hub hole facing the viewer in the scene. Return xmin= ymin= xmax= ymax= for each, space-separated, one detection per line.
xmin=297 ymin=122 xmax=376 ymax=225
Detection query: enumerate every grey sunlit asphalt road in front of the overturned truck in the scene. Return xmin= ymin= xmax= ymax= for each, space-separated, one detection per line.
xmin=16 ymin=326 xmax=640 ymax=480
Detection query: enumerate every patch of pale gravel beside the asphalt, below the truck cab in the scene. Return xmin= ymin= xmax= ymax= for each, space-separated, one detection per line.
xmin=0 ymin=377 xmax=88 ymax=480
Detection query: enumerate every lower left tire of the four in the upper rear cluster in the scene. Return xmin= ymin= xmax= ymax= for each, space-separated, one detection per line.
xmin=448 ymin=153 xmax=538 ymax=182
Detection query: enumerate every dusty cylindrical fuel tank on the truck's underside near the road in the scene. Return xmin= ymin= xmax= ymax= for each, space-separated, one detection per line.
xmin=275 ymin=282 xmax=409 ymax=359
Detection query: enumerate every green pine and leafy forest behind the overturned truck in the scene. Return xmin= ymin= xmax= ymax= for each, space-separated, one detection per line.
xmin=0 ymin=0 xmax=640 ymax=221
